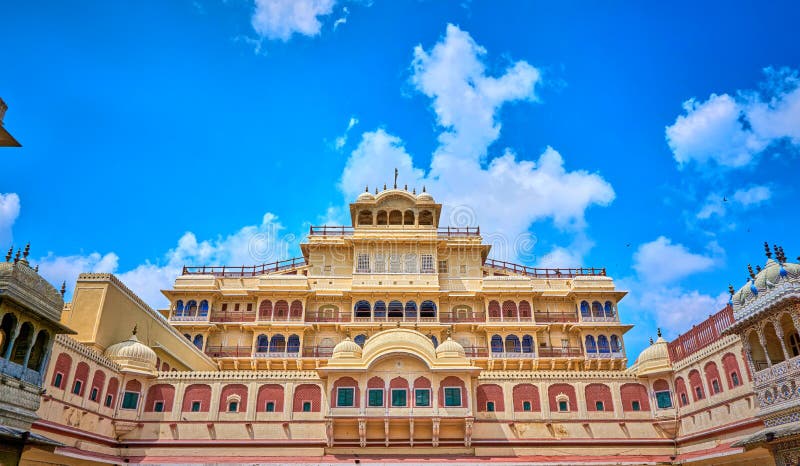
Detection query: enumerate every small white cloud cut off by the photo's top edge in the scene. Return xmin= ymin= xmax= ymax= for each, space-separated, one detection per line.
xmin=251 ymin=0 xmax=336 ymax=42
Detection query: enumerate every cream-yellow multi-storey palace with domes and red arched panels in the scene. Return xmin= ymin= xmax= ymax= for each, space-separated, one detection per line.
xmin=0 ymin=187 xmax=800 ymax=465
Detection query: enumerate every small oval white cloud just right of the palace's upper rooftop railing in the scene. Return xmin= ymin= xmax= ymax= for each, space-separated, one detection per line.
xmin=633 ymin=236 xmax=724 ymax=284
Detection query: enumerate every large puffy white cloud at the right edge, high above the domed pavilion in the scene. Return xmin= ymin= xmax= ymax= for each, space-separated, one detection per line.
xmin=666 ymin=68 xmax=800 ymax=168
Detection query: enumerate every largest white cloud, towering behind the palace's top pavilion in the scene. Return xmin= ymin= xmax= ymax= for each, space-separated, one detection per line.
xmin=340 ymin=25 xmax=614 ymax=262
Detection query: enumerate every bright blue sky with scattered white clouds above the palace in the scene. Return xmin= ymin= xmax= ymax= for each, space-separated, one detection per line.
xmin=0 ymin=0 xmax=800 ymax=359
